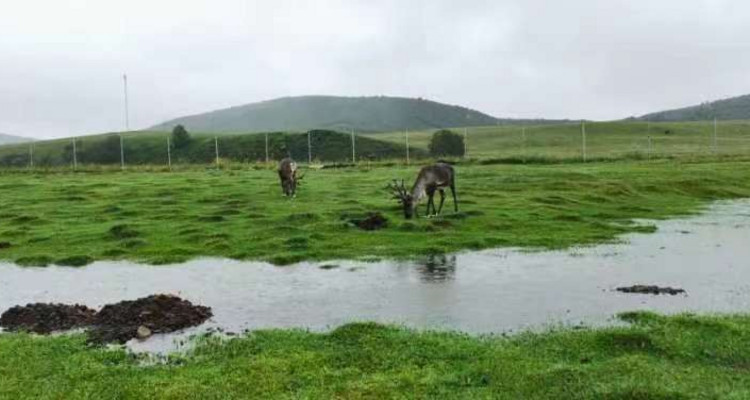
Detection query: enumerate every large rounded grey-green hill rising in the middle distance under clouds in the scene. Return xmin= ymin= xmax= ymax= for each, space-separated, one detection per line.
xmin=148 ymin=96 xmax=564 ymax=133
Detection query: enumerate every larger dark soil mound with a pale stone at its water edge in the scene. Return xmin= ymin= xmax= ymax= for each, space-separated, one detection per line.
xmin=89 ymin=294 xmax=213 ymax=344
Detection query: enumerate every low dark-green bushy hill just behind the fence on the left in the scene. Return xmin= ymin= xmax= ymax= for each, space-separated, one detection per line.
xmin=0 ymin=130 xmax=426 ymax=168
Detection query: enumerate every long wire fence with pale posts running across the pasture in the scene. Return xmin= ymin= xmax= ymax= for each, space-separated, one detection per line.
xmin=0 ymin=121 xmax=750 ymax=170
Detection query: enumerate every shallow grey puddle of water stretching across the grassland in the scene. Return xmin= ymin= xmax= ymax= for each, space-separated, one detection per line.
xmin=0 ymin=201 xmax=750 ymax=350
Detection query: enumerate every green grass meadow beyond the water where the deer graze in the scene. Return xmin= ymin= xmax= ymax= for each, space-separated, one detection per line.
xmin=0 ymin=159 xmax=750 ymax=266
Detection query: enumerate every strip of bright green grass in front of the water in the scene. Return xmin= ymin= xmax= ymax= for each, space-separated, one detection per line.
xmin=0 ymin=313 xmax=750 ymax=399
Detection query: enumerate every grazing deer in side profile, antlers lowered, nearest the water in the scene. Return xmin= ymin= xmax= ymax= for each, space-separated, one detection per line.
xmin=388 ymin=162 xmax=458 ymax=219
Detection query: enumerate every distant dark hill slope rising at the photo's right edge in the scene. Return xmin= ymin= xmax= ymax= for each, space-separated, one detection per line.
xmin=637 ymin=95 xmax=750 ymax=121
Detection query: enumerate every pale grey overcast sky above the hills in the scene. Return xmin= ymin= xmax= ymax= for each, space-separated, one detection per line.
xmin=0 ymin=0 xmax=750 ymax=138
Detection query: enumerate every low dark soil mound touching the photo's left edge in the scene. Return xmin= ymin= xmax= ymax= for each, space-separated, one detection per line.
xmin=0 ymin=303 xmax=96 ymax=334
